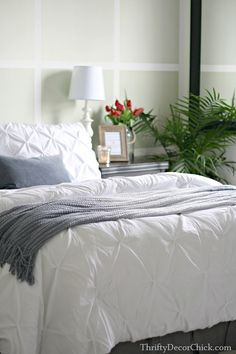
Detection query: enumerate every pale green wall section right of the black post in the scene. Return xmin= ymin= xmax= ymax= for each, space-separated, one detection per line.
xmin=201 ymin=0 xmax=236 ymax=184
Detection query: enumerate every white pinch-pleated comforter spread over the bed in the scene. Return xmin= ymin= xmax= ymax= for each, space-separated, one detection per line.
xmin=0 ymin=173 xmax=236 ymax=354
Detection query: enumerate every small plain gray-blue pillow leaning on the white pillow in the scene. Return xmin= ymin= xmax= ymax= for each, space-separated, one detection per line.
xmin=0 ymin=155 xmax=70 ymax=189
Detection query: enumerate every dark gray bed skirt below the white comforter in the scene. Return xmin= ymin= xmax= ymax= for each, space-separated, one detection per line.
xmin=110 ymin=321 xmax=236 ymax=354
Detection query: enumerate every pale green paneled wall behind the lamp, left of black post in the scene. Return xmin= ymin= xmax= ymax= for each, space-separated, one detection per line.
xmin=0 ymin=0 xmax=184 ymax=154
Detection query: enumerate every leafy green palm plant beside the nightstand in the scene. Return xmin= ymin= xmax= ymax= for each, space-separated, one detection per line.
xmin=135 ymin=90 xmax=236 ymax=182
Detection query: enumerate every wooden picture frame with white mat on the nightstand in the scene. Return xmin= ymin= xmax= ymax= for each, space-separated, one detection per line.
xmin=99 ymin=124 xmax=128 ymax=161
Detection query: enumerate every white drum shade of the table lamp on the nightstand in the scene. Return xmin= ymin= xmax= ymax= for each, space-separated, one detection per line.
xmin=69 ymin=66 xmax=105 ymax=101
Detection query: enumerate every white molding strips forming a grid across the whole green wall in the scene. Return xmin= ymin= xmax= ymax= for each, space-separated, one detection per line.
xmin=0 ymin=0 xmax=236 ymax=123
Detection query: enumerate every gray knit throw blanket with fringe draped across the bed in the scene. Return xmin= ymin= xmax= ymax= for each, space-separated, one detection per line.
xmin=0 ymin=186 xmax=236 ymax=284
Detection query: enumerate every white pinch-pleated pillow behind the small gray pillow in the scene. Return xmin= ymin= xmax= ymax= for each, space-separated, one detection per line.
xmin=0 ymin=123 xmax=101 ymax=183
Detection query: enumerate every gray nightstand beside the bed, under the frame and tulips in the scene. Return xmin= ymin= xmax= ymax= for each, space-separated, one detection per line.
xmin=99 ymin=161 xmax=169 ymax=178
